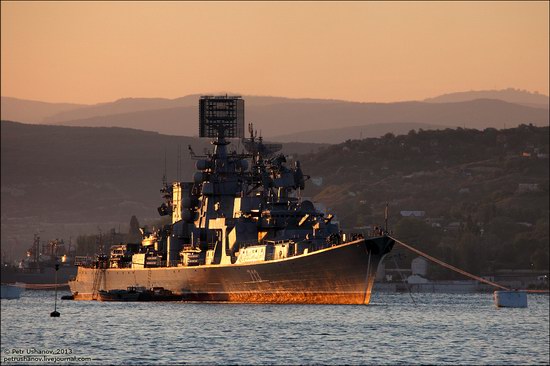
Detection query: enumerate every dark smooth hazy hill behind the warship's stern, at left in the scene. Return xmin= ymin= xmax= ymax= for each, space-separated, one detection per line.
xmin=1 ymin=121 xmax=322 ymax=254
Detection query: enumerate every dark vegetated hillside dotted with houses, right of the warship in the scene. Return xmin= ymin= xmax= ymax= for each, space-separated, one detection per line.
xmin=301 ymin=125 xmax=549 ymax=272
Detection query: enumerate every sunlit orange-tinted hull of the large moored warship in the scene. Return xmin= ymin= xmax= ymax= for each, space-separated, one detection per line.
xmin=69 ymin=236 xmax=394 ymax=304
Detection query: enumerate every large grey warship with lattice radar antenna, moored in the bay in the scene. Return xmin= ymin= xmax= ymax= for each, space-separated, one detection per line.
xmin=69 ymin=95 xmax=394 ymax=304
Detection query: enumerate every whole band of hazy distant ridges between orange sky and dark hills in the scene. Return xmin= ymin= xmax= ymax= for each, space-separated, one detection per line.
xmin=2 ymin=89 xmax=549 ymax=143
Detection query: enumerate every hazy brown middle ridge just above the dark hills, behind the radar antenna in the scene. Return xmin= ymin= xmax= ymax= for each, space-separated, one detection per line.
xmin=51 ymin=99 xmax=549 ymax=142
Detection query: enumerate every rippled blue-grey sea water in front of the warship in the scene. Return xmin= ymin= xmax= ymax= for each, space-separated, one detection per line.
xmin=1 ymin=291 xmax=550 ymax=365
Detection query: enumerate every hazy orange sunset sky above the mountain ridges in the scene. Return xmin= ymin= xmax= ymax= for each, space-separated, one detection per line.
xmin=1 ymin=1 xmax=549 ymax=103
